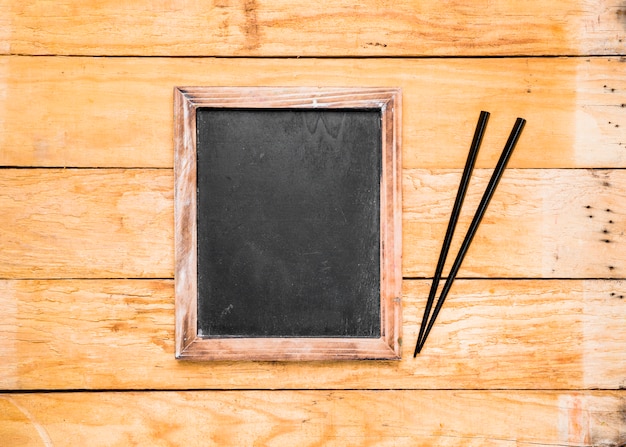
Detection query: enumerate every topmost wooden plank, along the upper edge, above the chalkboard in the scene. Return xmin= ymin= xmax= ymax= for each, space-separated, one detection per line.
xmin=0 ymin=0 xmax=626 ymax=56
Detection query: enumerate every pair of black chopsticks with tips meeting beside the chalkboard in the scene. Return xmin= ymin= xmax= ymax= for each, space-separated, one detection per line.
xmin=413 ymin=111 xmax=526 ymax=357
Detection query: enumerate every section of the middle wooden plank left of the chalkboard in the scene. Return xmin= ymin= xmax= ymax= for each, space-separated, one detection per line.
xmin=0 ymin=169 xmax=174 ymax=278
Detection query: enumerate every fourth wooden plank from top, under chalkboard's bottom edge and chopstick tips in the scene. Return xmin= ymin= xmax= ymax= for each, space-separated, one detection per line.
xmin=0 ymin=280 xmax=626 ymax=390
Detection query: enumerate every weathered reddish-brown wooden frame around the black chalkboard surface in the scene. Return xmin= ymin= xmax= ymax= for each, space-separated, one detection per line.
xmin=174 ymin=87 xmax=402 ymax=361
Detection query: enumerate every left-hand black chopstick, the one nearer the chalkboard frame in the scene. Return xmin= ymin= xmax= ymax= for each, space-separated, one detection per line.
xmin=413 ymin=111 xmax=489 ymax=357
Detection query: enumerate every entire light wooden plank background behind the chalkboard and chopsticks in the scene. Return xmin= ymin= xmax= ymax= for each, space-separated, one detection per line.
xmin=0 ymin=0 xmax=626 ymax=447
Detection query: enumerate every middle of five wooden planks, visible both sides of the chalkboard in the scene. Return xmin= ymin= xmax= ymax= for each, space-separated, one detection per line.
xmin=0 ymin=168 xmax=626 ymax=279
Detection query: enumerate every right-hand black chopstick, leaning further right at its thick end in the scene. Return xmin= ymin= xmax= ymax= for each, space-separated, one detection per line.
xmin=417 ymin=118 xmax=526 ymax=353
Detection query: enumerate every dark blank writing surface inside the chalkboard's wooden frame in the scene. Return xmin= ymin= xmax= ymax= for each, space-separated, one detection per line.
xmin=196 ymin=108 xmax=382 ymax=338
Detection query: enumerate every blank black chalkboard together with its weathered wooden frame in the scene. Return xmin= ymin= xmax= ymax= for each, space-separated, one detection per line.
xmin=174 ymin=87 xmax=402 ymax=361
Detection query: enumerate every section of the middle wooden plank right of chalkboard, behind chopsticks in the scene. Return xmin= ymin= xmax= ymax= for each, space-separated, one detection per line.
xmin=403 ymin=169 xmax=626 ymax=278
